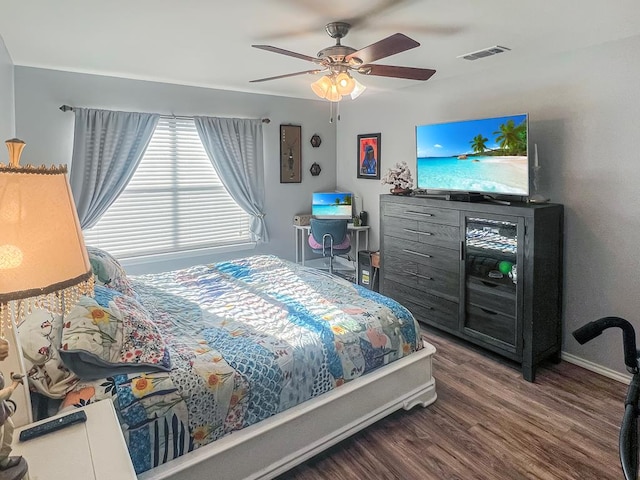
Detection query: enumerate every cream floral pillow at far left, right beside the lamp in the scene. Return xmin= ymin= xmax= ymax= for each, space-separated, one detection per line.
xmin=18 ymin=309 xmax=79 ymax=399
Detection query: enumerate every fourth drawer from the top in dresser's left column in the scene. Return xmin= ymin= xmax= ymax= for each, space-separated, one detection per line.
xmin=385 ymin=256 xmax=460 ymax=301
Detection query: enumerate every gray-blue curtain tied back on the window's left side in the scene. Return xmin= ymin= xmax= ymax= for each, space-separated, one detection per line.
xmin=69 ymin=108 xmax=160 ymax=229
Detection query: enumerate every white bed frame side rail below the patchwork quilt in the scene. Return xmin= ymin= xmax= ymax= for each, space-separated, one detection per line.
xmin=138 ymin=342 xmax=437 ymax=480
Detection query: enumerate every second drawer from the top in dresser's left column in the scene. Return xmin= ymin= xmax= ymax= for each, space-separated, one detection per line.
xmin=383 ymin=217 xmax=460 ymax=249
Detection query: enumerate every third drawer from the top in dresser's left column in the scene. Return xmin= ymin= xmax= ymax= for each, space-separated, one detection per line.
xmin=383 ymin=235 xmax=460 ymax=274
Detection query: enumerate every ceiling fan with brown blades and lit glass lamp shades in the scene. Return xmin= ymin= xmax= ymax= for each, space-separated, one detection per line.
xmin=251 ymin=22 xmax=436 ymax=102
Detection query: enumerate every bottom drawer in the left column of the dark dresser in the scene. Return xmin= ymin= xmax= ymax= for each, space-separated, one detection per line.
xmin=384 ymin=279 xmax=459 ymax=330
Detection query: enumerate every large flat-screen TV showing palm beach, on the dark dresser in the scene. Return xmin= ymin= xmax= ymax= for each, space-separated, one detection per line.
xmin=416 ymin=114 xmax=529 ymax=195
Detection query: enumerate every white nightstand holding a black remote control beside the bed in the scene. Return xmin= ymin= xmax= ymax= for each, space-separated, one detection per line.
xmin=11 ymin=400 xmax=136 ymax=480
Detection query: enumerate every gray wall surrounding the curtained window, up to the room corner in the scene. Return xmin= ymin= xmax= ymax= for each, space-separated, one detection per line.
xmin=13 ymin=66 xmax=336 ymax=273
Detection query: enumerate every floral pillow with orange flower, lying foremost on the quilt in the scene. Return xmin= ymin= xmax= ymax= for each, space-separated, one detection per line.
xmin=60 ymin=285 xmax=171 ymax=380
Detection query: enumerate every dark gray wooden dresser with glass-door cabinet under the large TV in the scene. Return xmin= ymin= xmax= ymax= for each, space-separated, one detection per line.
xmin=380 ymin=195 xmax=564 ymax=382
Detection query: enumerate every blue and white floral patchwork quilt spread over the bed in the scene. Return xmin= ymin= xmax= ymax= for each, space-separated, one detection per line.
xmin=58 ymin=256 xmax=421 ymax=473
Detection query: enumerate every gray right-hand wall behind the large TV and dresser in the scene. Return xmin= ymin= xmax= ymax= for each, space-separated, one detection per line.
xmin=337 ymin=37 xmax=640 ymax=372
